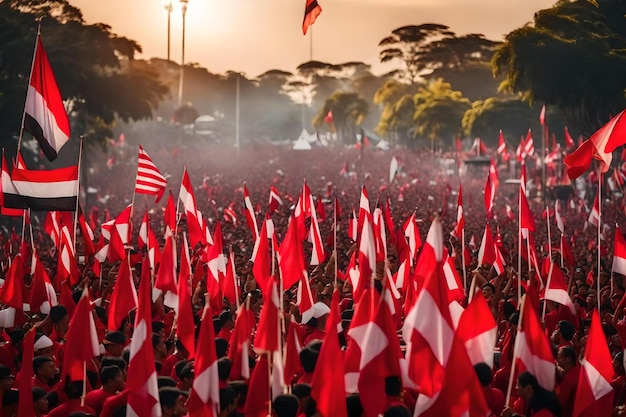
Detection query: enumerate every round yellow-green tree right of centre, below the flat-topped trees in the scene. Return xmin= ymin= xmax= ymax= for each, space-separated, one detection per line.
xmin=413 ymin=79 xmax=471 ymax=149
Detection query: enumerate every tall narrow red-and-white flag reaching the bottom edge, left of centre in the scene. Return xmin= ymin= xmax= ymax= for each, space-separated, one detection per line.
xmin=126 ymin=258 xmax=161 ymax=417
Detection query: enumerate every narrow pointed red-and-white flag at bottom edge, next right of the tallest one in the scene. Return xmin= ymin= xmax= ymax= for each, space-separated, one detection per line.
xmin=188 ymin=303 xmax=220 ymax=417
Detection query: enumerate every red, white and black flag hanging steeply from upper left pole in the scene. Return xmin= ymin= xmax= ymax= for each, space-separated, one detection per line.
xmin=24 ymin=35 xmax=70 ymax=161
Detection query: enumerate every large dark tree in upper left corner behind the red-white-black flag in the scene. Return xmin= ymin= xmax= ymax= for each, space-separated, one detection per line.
xmin=0 ymin=0 xmax=167 ymax=154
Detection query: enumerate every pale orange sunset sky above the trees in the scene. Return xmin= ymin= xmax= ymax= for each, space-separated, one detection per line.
xmin=70 ymin=0 xmax=555 ymax=77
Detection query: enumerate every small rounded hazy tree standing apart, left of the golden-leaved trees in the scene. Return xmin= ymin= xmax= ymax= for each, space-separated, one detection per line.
xmin=313 ymin=91 xmax=369 ymax=143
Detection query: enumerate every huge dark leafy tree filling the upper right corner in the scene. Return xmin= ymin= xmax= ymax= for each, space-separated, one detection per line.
xmin=492 ymin=0 xmax=626 ymax=135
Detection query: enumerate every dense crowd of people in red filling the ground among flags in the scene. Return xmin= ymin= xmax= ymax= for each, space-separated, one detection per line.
xmin=0 ymin=138 xmax=626 ymax=417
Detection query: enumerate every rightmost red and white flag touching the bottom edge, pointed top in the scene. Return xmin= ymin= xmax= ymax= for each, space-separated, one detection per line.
xmin=572 ymin=310 xmax=614 ymax=417
